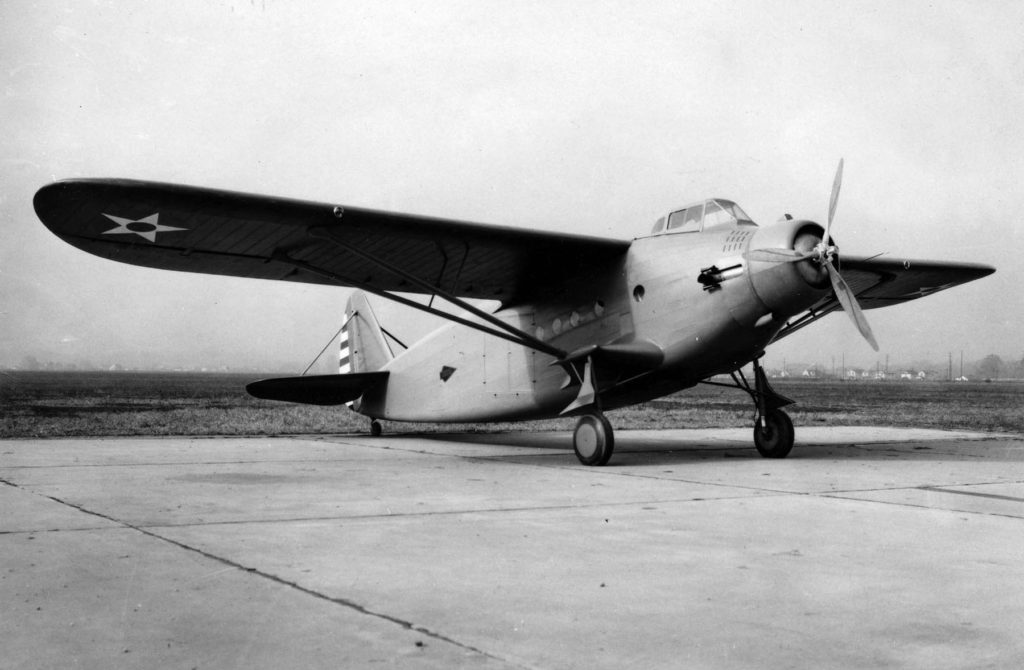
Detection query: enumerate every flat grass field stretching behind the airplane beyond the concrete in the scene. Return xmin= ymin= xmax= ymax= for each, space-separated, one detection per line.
xmin=0 ymin=372 xmax=1024 ymax=437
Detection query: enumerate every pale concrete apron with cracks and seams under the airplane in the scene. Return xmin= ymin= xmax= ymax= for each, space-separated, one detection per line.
xmin=0 ymin=427 xmax=1024 ymax=668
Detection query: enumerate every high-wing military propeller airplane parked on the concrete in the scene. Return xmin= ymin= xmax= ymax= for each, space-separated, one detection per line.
xmin=34 ymin=160 xmax=995 ymax=465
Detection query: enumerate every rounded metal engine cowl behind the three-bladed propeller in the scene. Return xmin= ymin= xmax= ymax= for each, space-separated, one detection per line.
xmin=746 ymin=221 xmax=829 ymax=319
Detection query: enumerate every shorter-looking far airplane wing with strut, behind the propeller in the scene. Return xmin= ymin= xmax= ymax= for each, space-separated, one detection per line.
xmin=775 ymin=255 xmax=995 ymax=341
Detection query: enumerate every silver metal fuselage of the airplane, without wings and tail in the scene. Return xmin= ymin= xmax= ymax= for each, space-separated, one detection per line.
xmin=357 ymin=221 xmax=827 ymax=422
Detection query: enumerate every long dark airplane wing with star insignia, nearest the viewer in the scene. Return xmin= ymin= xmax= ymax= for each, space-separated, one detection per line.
xmin=34 ymin=179 xmax=630 ymax=304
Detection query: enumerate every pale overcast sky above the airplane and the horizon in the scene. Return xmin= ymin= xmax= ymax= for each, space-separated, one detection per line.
xmin=0 ymin=0 xmax=1024 ymax=372
